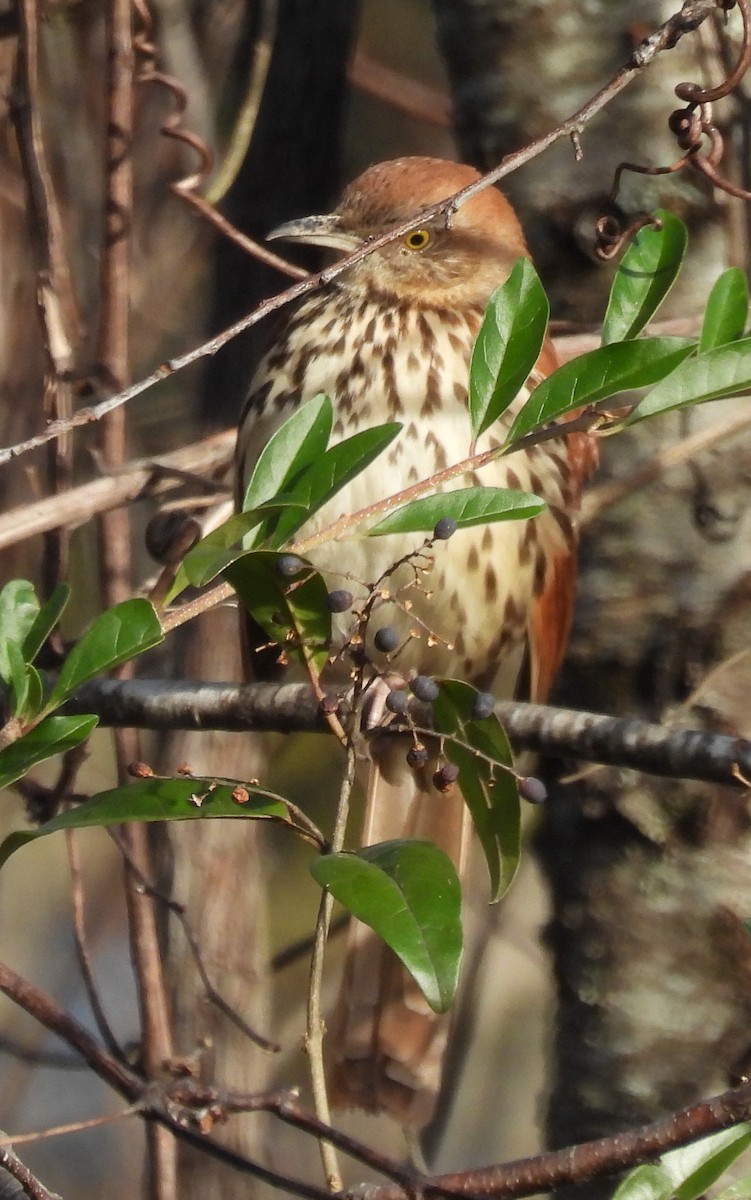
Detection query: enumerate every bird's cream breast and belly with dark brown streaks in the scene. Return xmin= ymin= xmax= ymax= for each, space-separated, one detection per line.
xmin=239 ymin=293 xmax=573 ymax=691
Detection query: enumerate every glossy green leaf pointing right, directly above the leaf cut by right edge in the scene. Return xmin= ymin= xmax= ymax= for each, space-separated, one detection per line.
xmin=509 ymin=337 xmax=696 ymax=444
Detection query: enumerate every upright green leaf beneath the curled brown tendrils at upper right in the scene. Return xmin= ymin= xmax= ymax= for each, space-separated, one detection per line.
xmin=602 ymin=209 xmax=687 ymax=346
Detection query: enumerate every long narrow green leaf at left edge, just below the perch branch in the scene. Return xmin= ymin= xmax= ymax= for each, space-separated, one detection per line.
xmin=0 ymin=777 xmax=287 ymax=866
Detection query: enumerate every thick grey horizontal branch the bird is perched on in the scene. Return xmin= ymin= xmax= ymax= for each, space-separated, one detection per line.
xmin=66 ymin=679 xmax=751 ymax=785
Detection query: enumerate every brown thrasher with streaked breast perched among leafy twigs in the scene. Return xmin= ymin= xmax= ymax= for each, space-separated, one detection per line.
xmin=238 ymin=157 xmax=595 ymax=1126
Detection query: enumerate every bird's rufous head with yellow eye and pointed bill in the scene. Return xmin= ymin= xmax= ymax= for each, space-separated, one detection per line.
xmin=269 ymin=157 xmax=528 ymax=306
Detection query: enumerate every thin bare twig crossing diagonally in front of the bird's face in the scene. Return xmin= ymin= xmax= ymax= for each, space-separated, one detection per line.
xmin=0 ymin=0 xmax=715 ymax=466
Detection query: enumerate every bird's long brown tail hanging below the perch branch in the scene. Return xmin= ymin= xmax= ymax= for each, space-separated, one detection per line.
xmin=330 ymin=738 xmax=469 ymax=1128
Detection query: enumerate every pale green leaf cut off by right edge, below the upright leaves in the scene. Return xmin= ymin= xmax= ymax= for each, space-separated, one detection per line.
xmin=626 ymin=337 xmax=751 ymax=425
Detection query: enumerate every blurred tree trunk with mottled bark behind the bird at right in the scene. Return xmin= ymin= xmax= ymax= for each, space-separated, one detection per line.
xmin=433 ymin=0 xmax=751 ymax=1195
